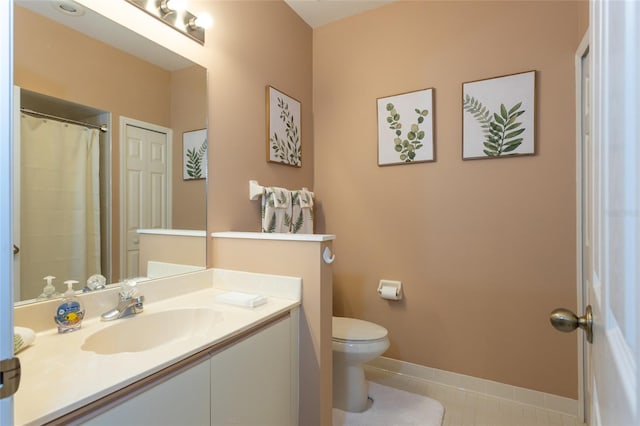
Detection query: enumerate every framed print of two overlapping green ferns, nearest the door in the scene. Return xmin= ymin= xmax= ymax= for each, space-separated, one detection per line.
xmin=462 ymin=71 xmax=535 ymax=160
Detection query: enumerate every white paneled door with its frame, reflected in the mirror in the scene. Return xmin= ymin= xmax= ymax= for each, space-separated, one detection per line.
xmin=120 ymin=120 xmax=171 ymax=278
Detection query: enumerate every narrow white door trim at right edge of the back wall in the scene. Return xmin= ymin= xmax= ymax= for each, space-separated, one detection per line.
xmin=575 ymin=29 xmax=589 ymax=423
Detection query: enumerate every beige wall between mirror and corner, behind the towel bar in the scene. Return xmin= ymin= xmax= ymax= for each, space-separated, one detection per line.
xmin=201 ymin=1 xmax=314 ymax=236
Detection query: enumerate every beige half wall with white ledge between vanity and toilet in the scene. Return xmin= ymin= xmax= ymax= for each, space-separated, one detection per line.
xmin=212 ymin=232 xmax=335 ymax=426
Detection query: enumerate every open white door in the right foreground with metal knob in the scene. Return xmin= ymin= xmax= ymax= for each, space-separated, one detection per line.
xmin=584 ymin=0 xmax=640 ymax=426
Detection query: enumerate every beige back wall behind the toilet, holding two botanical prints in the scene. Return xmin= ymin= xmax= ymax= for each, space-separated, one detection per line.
xmin=313 ymin=1 xmax=587 ymax=398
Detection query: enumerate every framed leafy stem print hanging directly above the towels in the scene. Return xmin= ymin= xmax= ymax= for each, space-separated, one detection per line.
xmin=266 ymin=86 xmax=302 ymax=167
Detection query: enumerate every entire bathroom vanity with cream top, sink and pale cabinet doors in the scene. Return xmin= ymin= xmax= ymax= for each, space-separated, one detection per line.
xmin=15 ymin=269 xmax=301 ymax=425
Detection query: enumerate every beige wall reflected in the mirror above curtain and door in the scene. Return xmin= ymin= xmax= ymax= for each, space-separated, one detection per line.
xmin=14 ymin=7 xmax=207 ymax=279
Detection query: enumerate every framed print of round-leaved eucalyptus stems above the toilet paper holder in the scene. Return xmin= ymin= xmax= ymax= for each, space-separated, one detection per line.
xmin=377 ymin=88 xmax=435 ymax=166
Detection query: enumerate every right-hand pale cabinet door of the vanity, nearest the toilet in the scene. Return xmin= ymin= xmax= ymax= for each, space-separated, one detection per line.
xmin=211 ymin=318 xmax=298 ymax=426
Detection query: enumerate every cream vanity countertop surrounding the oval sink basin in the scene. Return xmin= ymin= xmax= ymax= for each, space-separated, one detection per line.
xmin=14 ymin=270 xmax=300 ymax=425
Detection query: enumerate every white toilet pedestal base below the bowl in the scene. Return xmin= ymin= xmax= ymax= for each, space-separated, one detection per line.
xmin=333 ymin=357 xmax=369 ymax=413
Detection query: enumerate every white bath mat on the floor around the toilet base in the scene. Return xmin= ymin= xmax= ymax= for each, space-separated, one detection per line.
xmin=333 ymin=382 xmax=444 ymax=426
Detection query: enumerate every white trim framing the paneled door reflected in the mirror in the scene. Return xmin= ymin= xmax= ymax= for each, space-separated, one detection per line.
xmin=119 ymin=116 xmax=173 ymax=279
